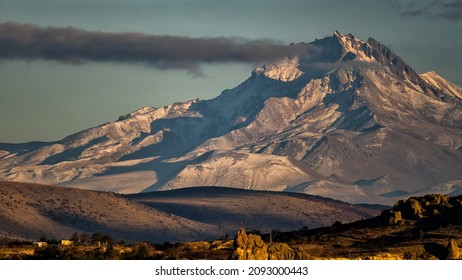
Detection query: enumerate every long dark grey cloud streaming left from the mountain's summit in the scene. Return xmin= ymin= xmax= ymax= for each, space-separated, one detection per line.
xmin=0 ymin=22 xmax=312 ymax=74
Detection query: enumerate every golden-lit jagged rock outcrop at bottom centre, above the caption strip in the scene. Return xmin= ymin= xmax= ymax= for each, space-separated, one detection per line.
xmin=229 ymin=228 xmax=310 ymax=260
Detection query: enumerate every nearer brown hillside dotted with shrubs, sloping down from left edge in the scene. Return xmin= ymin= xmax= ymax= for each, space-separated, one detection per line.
xmin=0 ymin=182 xmax=216 ymax=242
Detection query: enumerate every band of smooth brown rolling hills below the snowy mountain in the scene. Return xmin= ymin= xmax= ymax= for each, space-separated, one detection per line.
xmin=0 ymin=182 xmax=377 ymax=242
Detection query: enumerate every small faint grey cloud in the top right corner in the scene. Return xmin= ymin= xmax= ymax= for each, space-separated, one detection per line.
xmin=401 ymin=0 xmax=462 ymax=21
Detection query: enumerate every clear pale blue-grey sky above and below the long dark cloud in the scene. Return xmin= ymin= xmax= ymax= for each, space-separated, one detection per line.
xmin=0 ymin=0 xmax=462 ymax=142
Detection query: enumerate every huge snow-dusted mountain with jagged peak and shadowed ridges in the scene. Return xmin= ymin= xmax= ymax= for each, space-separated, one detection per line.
xmin=0 ymin=32 xmax=462 ymax=204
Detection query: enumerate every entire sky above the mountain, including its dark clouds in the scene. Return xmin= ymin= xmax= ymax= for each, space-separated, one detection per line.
xmin=0 ymin=0 xmax=462 ymax=143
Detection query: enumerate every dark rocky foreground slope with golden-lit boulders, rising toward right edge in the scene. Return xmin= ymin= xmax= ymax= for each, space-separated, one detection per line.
xmin=249 ymin=194 xmax=462 ymax=260
